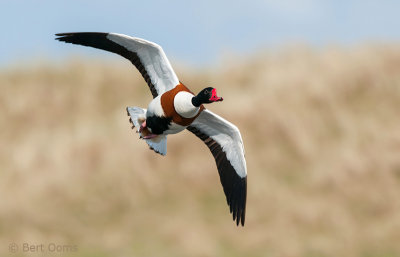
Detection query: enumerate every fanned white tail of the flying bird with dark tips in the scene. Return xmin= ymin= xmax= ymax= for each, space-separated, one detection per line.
xmin=126 ymin=107 xmax=167 ymax=155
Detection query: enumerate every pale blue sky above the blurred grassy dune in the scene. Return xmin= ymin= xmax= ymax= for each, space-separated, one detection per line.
xmin=0 ymin=0 xmax=400 ymax=65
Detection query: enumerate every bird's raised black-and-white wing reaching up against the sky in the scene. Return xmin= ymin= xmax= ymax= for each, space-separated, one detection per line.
xmin=56 ymin=32 xmax=179 ymax=98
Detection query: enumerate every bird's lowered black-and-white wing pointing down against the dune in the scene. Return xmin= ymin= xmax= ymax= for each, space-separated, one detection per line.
xmin=187 ymin=110 xmax=247 ymax=226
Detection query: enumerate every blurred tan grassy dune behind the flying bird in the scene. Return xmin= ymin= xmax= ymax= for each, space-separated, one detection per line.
xmin=0 ymin=45 xmax=400 ymax=257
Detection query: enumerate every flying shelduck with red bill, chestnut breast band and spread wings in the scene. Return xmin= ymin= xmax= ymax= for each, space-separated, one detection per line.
xmin=56 ymin=32 xmax=247 ymax=226
